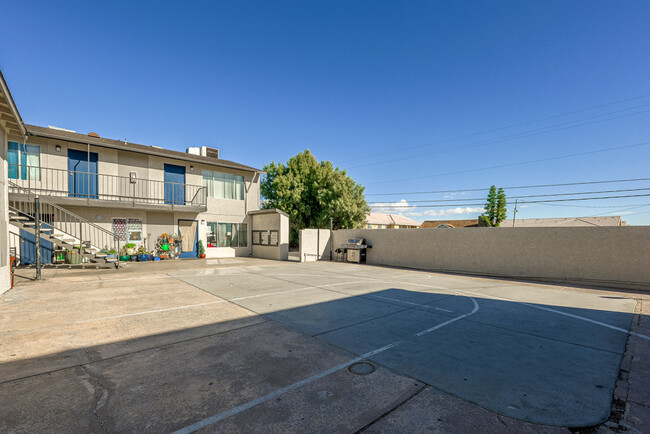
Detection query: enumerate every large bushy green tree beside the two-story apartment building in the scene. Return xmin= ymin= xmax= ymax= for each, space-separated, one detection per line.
xmin=260 ymin=149 xmax=370 ymax=246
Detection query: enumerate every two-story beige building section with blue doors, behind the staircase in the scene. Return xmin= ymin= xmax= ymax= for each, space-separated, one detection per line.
xmin=7 ymin=125 xmax=261 ymax=257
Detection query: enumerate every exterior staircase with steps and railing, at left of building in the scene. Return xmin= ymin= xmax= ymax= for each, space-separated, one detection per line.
xmin=8 ymin=181 xmax=119 ymax=267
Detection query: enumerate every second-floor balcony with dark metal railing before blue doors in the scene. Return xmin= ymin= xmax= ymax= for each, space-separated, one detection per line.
xmin=8 ymin=164 xmax=207 ymax=211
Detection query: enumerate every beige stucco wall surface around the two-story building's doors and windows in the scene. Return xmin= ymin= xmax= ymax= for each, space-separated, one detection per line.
xmin=8 ymin=137 xmax=260 ymax=258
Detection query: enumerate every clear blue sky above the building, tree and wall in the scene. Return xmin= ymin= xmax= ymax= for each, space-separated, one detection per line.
xmin=0 ymin=0 xmax=650 ymax=224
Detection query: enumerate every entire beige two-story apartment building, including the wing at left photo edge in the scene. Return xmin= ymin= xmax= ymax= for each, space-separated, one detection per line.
xmin=0 ymin=68 xmax=274 ymax=293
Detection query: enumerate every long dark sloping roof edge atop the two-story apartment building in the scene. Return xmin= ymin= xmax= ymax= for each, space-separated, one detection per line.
xmin=25 ymin=125 xmax=264 ymax=173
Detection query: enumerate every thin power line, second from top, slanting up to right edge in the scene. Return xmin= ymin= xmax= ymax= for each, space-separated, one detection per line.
xmin=348 ymin=104 xmax=650 ymax=169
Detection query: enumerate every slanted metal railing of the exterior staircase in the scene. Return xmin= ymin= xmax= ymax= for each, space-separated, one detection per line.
xmin=8 ymin=181 xmax=120 ymax=252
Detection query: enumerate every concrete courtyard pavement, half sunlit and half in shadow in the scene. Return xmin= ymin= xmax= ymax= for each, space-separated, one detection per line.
xmin=0 ymin=258 xmax=650 ymax=433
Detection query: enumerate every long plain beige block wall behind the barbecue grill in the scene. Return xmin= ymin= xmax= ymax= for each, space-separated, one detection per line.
xmin=334 ymin=226 xmax=650 ymax=290
